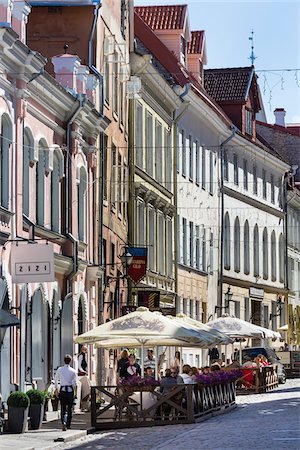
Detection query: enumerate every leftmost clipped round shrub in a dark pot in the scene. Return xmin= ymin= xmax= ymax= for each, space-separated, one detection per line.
xmin=7 ymin=391 xmax=29 ymax=433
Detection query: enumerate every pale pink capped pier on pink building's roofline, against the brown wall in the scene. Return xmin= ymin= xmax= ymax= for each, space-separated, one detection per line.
xmin=51 ymin=53 xmax=81 ymax=93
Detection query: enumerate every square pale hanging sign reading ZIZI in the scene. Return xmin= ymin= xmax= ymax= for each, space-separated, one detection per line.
xmin=10 ymin=243 xmax=55 ymax=283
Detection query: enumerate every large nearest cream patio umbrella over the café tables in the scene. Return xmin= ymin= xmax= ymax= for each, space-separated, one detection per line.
xmin=75 ymin=307 xmax=220 ymax=369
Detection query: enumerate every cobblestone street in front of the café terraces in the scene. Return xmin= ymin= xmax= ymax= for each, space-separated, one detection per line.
xmin=61 ymin=380 xmax=300 ymax=450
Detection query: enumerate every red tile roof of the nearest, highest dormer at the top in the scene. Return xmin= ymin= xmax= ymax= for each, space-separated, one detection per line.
xmin=134 ymin=5 xmax=187 ymax=30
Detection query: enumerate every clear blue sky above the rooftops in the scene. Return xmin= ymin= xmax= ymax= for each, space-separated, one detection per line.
xmin=134 ymin=0 xmax=300 ymax=123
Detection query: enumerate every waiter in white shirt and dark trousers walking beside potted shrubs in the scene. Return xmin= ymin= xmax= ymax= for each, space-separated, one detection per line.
xmin=54 ymin=355 xmax=78 ymax=431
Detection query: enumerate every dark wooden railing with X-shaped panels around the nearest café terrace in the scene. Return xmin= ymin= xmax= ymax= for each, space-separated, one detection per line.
xmin=91 ymin=382 xmax=236 ymax=430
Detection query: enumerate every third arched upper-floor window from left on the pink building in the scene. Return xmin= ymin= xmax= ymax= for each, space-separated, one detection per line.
xmin=35 ymin=139 xmax=48 ymax=226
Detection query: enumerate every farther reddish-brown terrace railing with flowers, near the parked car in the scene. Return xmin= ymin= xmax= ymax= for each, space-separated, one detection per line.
xmin=236 ymin=365 xmax=278 ymax=394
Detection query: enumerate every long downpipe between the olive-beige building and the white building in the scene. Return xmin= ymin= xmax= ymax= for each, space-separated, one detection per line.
xmin=173 ymin=83 xmax=191 ymax=312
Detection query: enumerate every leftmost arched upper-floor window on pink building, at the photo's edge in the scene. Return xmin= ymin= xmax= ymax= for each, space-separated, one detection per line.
xmin=0 ymin=114 xmax=12 ymax=208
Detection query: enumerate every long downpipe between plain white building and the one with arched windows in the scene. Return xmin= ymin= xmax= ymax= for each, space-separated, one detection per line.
xmin=218 ymin=125 xmax=237 ymax=316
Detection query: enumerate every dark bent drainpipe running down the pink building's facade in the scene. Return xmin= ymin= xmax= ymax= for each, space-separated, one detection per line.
xmin=65 ymin=94 xmax=86 ymax=293
